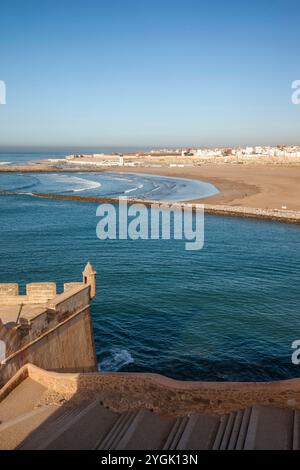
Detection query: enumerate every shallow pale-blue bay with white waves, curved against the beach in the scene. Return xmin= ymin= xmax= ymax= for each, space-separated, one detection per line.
xmin=0 ymin=172 xmax=219 ymax=202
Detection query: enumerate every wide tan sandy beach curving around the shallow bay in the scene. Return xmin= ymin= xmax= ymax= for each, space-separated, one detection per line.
xmin=109 ymin=164 xmax=300 ymax=211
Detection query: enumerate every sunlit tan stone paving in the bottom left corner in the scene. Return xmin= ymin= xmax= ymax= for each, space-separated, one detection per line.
xmin=0 ymin=405 xmax=59 ymax=450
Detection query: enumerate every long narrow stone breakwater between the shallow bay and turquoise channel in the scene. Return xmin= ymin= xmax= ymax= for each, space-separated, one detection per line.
xmin=0 ymin=191 xmax=300 ymax=224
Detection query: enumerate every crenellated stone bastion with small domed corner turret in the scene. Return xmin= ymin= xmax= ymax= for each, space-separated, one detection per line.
xmin=0 ymin=264 xmax=97 ymax=386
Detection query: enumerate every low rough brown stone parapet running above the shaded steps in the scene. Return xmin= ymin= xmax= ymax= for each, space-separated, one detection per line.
xmin=0 ymin=364 xmax=300 ymax=416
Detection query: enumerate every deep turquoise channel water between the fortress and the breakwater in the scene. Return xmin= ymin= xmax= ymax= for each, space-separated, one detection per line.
xmin=0 ymin=195 xmax=300 ymax=380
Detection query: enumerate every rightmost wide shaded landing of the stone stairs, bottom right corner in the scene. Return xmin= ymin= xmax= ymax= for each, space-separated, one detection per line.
xmin=244 ymin=406 xmax=294 ymax=450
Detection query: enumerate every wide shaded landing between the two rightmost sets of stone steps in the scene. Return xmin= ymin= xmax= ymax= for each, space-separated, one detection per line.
xmin=176 ymin=414 xmax=220 ymax=450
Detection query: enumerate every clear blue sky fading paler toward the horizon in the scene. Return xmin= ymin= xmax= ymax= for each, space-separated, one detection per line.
xmin=0 ymin=0 xmax=300 ymax=147
